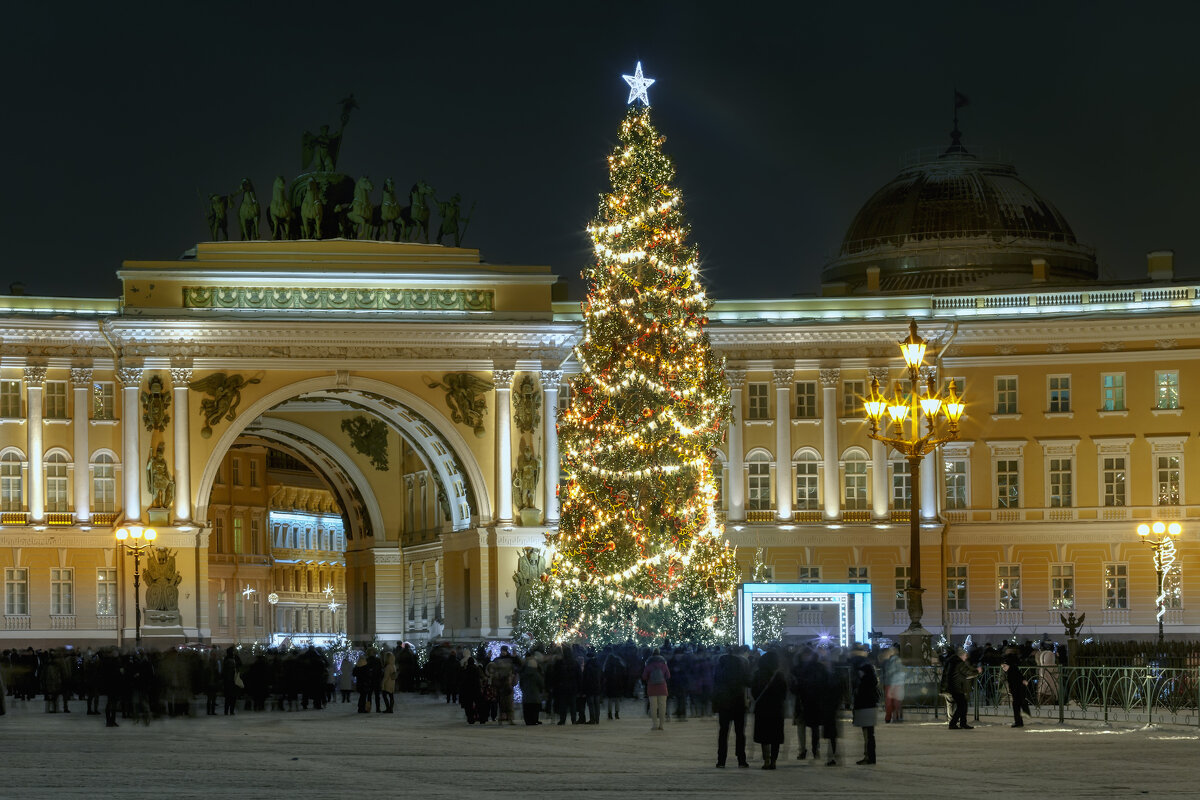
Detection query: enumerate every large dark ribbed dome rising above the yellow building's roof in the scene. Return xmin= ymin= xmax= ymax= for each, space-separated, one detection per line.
xmin=822 ymin=137 xmax=1097 ymax=294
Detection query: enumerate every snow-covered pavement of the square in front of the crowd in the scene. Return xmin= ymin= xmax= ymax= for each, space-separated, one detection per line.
xmin=0 ymin=696 xmax=1200 ymax=800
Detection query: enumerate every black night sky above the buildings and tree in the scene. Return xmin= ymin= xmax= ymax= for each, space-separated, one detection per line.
xmin=0 ymin=0 xmax=1200 ymax=297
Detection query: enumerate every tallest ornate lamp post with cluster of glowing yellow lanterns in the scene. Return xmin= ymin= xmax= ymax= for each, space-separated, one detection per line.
xmin=863 ymin=320 xmax=965 ymax=663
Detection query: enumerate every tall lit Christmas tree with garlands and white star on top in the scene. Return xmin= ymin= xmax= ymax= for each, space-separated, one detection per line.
xmin=518 ymin=64 xmax=738 ymax=643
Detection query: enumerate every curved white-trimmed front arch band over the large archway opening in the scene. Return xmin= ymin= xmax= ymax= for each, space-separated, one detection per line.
xmin=196 ymin=375 xmax=492 ymax=533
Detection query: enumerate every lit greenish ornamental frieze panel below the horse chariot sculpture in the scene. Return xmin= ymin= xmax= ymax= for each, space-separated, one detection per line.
xmin=184 ymin=287 xmax=496 ymax=312
